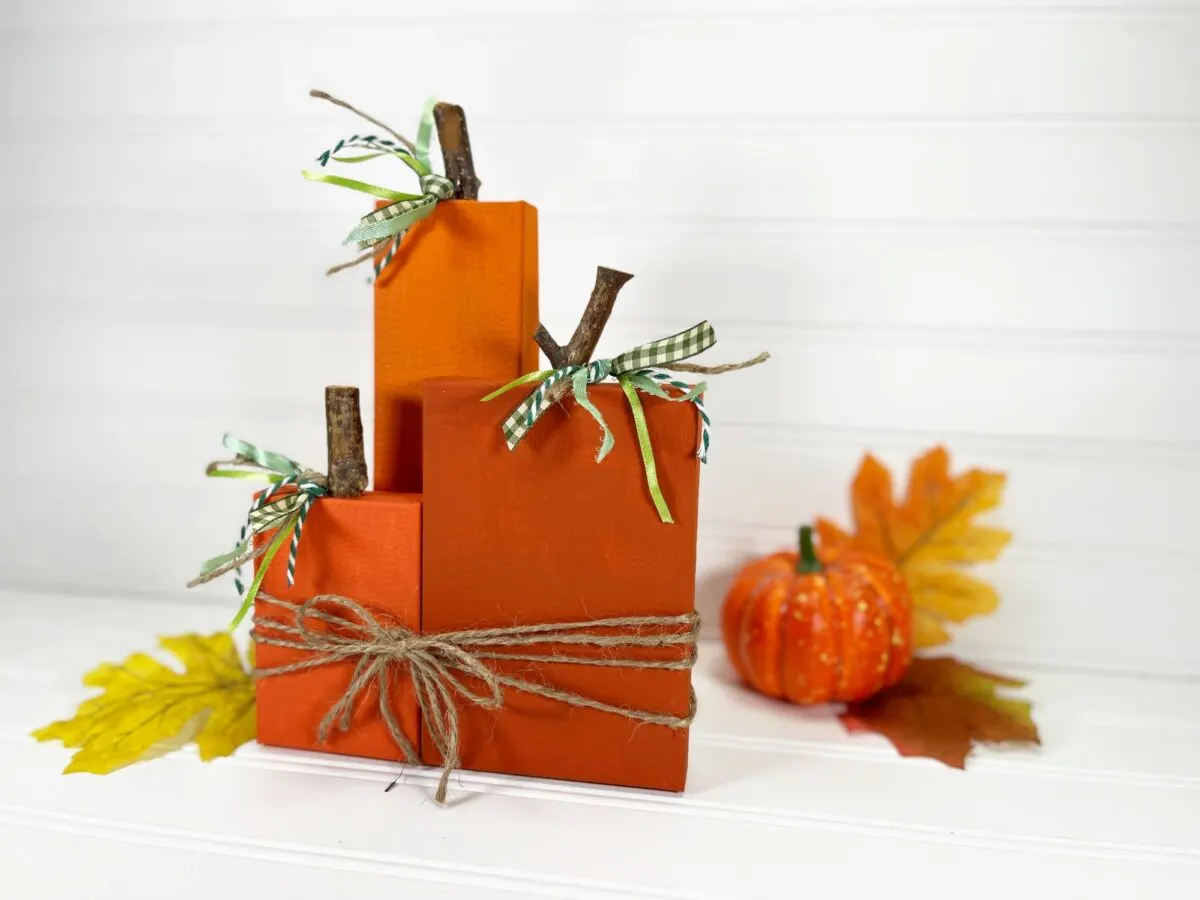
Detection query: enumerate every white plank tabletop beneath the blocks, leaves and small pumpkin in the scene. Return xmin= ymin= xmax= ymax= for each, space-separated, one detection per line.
xmin=0 ymin=592 xmax=1200 ymax=900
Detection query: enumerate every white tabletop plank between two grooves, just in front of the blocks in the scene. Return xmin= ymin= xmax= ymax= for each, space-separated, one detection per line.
xmin=7 ymin=746 xmax=1195 ymax=900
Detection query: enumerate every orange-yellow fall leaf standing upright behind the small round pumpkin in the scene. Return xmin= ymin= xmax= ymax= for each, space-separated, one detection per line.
xmin=817 ymin=446 xmax=1012 ymax=647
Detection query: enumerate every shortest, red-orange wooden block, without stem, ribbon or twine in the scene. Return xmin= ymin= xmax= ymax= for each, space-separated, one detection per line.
xmin=254 ymin=493 xmax=421 ymax=760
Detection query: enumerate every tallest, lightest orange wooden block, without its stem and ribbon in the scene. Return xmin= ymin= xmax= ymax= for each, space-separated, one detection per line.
xmin=373 ymin=200 xmax=538 ymax=493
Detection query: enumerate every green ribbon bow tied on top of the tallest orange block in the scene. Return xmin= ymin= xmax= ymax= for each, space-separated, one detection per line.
xmin=301 ymin=98 xmax=454 ymax=277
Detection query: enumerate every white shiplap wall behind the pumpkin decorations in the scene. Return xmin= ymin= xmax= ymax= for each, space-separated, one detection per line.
xmin=0 ymin=0 xmax=1200 ymax=674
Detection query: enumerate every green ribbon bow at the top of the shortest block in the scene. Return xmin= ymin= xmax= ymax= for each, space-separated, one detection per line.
xmin=188 ymin=434 xmax=326 ymax=628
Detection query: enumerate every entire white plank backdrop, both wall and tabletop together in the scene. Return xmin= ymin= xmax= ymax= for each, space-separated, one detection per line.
xmin=0 ymin=0 xmax=1200 ymax=899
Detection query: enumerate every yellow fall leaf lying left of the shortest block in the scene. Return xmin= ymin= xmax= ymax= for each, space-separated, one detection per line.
xmin=32 ymin=631 xmax=254 ymax=775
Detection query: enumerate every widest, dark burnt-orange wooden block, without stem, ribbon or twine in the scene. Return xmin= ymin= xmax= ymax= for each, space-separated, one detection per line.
xmin=421 ymin=378 xmax=700 ymax=791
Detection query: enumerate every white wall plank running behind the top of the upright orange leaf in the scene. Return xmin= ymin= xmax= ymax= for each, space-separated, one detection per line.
xmin=0 ymin=386 xmax=1200 ymax=559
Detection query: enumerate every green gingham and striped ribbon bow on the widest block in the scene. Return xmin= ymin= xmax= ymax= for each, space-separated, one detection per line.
xmin=484 ymin=322 xmax=716 ymax=524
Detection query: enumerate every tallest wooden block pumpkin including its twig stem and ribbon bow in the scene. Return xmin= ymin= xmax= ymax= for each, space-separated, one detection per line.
xmin=304 ymin=91 xmax=538 ymax=493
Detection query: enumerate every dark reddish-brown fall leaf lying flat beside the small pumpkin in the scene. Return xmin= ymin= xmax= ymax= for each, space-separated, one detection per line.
xmin=840 ymin=656 xmax=1042 ymax=769
